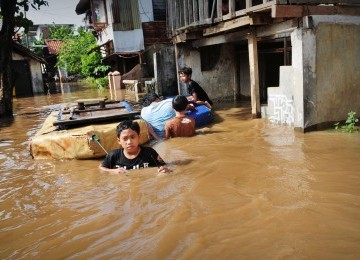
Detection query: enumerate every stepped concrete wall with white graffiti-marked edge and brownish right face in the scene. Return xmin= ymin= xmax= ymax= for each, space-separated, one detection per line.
xmin=266 ymin=16 xmax=360 ymax=131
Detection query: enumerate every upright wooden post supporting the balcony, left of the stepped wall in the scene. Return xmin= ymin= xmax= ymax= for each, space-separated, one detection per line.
xmin=248 ymin=33 xmax=261 ymax=118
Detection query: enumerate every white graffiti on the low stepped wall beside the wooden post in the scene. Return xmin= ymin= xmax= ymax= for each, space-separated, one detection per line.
xmin=268 ymin=95 xmax=294 ymax=125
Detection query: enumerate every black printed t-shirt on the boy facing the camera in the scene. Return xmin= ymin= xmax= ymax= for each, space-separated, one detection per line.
xmin=101 ymin=146 xmax=165 ymax=170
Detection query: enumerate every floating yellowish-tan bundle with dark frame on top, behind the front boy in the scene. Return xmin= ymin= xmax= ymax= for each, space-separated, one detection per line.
xmin=30 ymin=102 xmax=150 ymax=159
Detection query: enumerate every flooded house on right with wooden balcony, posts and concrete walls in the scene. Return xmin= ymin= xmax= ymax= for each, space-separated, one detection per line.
xmin=166 ymin=0 xmax=360 ymax=131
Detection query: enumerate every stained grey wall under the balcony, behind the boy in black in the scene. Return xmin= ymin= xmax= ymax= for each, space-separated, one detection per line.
xmin=177 ymin=44 xmax=238 ymax=100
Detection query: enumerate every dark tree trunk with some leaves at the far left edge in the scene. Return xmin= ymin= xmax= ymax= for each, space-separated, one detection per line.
xmin=0 ymin=0 xmax=48 ymax=117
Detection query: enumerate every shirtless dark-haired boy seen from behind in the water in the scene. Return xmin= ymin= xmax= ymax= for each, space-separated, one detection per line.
xmin=164 ymin=96 xmax=195 ymax=139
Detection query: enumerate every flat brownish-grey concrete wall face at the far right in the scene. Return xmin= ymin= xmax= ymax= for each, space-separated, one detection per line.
xmin=314 ymin=23 xmax=360 ymax=124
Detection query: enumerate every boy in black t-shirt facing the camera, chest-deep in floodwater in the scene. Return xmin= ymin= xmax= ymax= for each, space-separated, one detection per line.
xmin=99 ymin=120 xmax=170 ymax=173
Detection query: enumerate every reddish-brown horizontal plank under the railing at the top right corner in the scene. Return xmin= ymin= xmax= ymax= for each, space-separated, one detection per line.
xmin=271 ymin=5 xmax=360 ymax=18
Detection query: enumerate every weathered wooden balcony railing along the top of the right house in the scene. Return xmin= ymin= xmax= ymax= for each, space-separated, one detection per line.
xmin=167 ymin=0 xmax=360 ymax=36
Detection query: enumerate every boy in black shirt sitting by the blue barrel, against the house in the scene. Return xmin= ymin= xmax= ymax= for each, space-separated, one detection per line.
xmin=179 ymin=67 xmax=213 ymax=109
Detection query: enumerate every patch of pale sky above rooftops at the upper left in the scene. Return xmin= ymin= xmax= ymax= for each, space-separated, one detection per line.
xmin=26 ymin=0 xmax=85 ymax=26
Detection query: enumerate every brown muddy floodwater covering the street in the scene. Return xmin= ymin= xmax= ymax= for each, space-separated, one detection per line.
xmin=0 ymin=86 xmax=360 ymax=259
